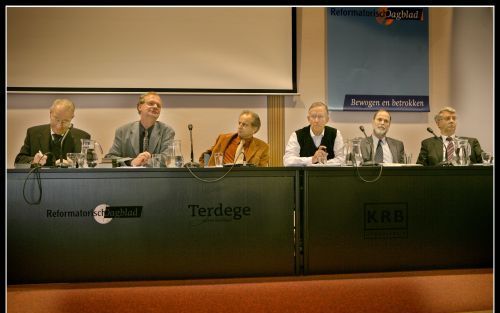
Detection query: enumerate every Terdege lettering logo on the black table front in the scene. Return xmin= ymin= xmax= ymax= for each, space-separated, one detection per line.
xmin=187 ymin=202 xmax=252 ymax=226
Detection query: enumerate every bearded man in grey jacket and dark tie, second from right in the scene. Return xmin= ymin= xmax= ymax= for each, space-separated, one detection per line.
xmin=361 ymin=110 xmax=405 ymax=163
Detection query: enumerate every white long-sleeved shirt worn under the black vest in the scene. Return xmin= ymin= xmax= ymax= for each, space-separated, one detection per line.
xmin=283 ymin=129 xmax=345 ymax=166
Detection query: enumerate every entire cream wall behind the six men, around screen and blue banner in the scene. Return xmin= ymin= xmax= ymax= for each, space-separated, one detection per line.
xmin=6 ymin=8 xmax=494 ymax=168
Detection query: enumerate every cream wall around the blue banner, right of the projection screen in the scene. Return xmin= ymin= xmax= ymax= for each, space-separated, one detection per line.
xmin=285 ymin=8 xmax=494 ymax=162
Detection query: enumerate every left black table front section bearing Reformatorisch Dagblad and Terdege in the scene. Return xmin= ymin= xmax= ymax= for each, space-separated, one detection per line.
xmin=7 ymin=169 xmax=297 ymax=283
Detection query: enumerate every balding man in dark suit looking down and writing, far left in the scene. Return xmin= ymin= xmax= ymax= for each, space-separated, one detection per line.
xmin=14 ymin=99 xmax=90 ymax=166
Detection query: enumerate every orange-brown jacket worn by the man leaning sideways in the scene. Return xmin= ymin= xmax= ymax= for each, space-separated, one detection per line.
xmin=199 ymin=133 xmax=269 ymax=166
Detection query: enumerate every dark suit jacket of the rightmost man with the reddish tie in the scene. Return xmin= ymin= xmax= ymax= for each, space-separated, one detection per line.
xmin=417 ymin=137 xmax=483 ymax=165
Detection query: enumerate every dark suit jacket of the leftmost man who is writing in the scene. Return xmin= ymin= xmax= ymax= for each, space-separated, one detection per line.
xmin=14 ymin=124 xmax=90 ymax=166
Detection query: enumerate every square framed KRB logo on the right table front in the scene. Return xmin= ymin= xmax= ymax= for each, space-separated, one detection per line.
xmin=363 ymin=203 xmax=408 ymax=239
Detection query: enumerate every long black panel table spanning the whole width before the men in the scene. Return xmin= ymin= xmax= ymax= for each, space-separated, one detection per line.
xmin=6 ymin=166 xmax=494 ymax=284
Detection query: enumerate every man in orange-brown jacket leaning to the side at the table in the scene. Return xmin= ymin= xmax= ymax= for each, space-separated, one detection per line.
xmin=199 ymin=110 xmax=269 ymax=166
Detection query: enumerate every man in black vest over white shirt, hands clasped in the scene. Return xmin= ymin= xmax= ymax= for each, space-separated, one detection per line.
xmin=283 ymin=102 xmax=345 ymax=166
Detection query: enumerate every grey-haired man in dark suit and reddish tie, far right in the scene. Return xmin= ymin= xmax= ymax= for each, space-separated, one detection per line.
xmin=417 ymin=107 xmax=482 ymax=165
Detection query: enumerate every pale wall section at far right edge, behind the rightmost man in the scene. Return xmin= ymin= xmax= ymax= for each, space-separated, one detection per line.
xmin=451 ymin=8 xmax=495 ymax=151
